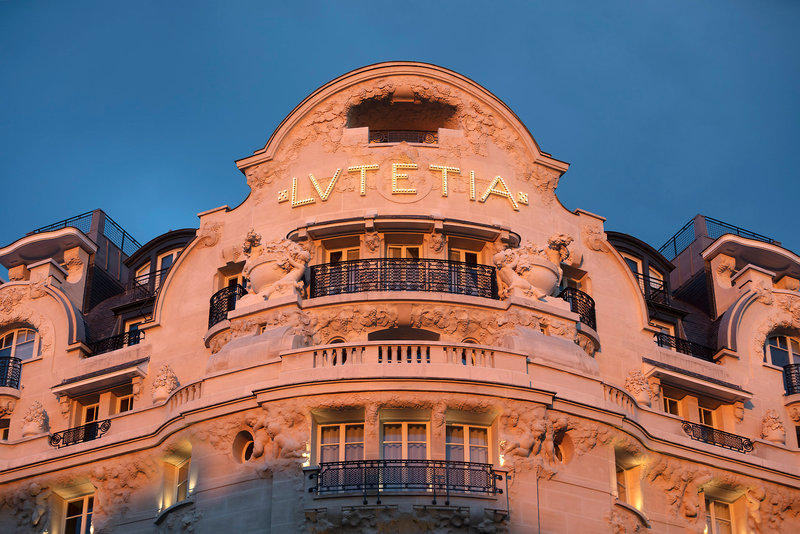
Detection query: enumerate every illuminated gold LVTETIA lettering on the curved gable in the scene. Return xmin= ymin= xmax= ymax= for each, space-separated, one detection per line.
xmin=278 ymin=163 xmax=528 ymax=211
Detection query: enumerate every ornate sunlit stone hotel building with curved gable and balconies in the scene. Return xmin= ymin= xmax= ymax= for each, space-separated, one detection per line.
xmin=0 ymin=62 xmax=800 ymax=534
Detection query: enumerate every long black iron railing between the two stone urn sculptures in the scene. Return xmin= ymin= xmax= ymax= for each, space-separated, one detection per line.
xmin=309 ymin=258 xmax=498 ymax=299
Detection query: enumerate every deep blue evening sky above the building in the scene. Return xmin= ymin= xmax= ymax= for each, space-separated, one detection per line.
xmin=0 ymin=0 xmax=800 ymax=266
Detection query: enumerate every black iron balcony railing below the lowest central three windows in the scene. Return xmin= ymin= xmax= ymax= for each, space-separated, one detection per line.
xmin=310 ymin=460 xmax=502 ymax=503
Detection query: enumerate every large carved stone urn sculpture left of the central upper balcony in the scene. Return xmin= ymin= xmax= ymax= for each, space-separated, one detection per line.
xmin=242 ymin=230 xmax=311 ymax=300
